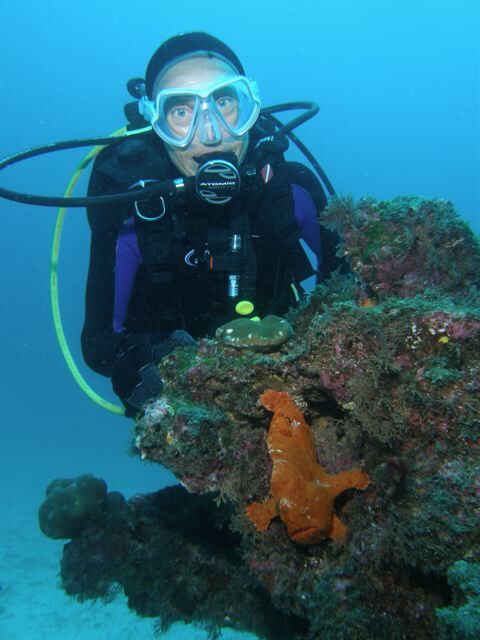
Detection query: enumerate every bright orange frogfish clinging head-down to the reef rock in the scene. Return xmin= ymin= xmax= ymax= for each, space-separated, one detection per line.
xmin=246 ymin=389 xmax=370 ymax=544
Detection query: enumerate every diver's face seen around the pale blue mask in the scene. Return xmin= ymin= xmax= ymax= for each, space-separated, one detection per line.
xmin=153 ymin=56 xmax=248 ymax=176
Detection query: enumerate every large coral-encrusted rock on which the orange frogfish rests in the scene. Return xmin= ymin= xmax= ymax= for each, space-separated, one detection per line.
xmin=53 ymin=197 xmax=480 ymax=640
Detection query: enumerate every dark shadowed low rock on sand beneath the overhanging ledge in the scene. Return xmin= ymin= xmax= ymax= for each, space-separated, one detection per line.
xmin=61 ymin=486 xmax=306 ymax=640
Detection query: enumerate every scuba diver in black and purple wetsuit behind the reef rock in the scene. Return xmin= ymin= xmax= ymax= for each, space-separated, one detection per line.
xmin=82 ymin=32 xmax=337 ymax=417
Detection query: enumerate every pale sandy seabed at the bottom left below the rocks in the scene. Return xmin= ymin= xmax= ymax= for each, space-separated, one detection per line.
xmin=0 ymin=497 xmax=255 ymax=640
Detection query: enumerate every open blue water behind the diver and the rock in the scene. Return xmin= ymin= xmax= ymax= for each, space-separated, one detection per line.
xmin=0 ymin=0 xmax=480 ymax=632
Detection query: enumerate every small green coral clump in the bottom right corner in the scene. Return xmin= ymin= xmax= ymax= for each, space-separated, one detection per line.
xmin=436 ymin=560 xmax=480 ymax=640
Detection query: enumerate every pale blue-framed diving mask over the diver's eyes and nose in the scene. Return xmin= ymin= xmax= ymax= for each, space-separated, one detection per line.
xmin=139 ymin=76 xmax=260 ymax=148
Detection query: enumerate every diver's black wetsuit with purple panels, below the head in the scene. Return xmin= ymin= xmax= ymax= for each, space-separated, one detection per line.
xmin=82 ymin=134 xmax=334 ymax=376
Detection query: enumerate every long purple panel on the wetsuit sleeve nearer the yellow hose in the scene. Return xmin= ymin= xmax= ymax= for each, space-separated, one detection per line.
xmin=113 ymin=219 xmax=141 ymax=333
